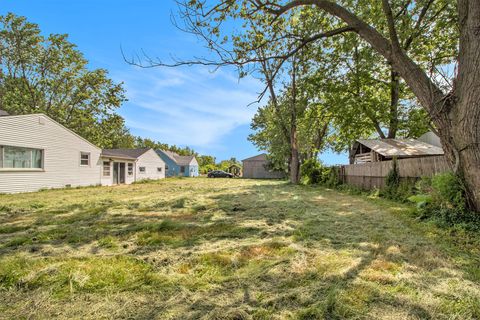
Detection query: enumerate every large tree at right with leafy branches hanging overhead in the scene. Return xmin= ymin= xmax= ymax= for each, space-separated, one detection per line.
xmin=144 ymin=0 xmax=480 ymax=211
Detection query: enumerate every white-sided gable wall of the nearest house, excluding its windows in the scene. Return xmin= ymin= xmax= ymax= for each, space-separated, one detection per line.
xmin=0 ymin=114 xmax=101 ymax=193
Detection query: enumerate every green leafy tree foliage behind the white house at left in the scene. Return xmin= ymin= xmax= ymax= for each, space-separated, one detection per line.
xmin=0 ymin=13 xmax=132 ymax=147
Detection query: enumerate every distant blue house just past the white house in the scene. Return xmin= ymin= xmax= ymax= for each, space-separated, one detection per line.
xmin=156 ymin=150 xmax=198 ymax=177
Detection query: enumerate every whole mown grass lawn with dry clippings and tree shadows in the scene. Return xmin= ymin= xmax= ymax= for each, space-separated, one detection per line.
xmin=0 ymin=178 xmax=480 ymax=319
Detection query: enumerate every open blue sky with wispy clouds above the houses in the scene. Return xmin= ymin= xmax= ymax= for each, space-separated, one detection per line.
xmin=0 ymin=0 xmax=347 ymax=164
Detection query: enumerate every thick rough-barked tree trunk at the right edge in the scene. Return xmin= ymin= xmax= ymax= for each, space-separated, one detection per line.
xmin=442 ymin=0 xmax=480 ymax=212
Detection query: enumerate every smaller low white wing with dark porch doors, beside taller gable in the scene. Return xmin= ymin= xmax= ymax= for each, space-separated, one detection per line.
xmin=101 ymin=148 xmax=165 ymax=185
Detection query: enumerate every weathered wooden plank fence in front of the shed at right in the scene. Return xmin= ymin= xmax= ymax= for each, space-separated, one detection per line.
xmin=339 ymin=156 xmax=449 ymax=190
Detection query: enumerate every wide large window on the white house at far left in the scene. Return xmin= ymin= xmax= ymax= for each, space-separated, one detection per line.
xmin=0 ymin=146 xmax=43 ymax=169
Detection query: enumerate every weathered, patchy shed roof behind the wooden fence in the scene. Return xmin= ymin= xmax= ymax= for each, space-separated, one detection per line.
xmin=357 ymin=139 xmax=444 ymax=157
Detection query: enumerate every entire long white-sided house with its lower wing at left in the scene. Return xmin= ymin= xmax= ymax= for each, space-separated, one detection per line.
xmin=0 ymin=113 xmax=165 ymax=193
